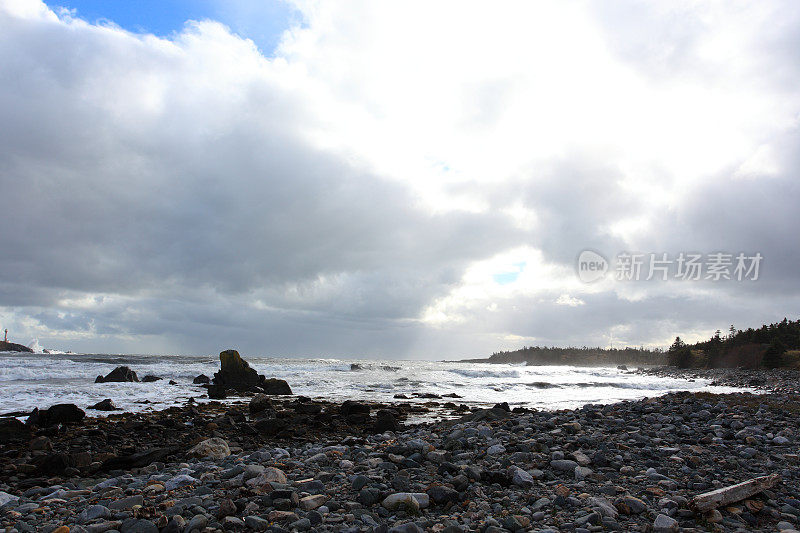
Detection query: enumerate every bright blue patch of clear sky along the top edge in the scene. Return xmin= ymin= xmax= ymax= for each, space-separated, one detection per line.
xmin=45 ymin=0 xmax=301 ymax=56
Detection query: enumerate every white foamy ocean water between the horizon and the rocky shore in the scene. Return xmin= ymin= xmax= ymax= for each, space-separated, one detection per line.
xmin=0 ymin=353 xmax=744 ymax=416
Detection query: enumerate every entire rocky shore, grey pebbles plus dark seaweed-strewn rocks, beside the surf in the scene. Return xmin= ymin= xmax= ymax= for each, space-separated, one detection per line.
xmin=0 ymin=368 xmax=800 ymax=533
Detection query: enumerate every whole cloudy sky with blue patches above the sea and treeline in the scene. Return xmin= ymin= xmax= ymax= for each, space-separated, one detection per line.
xmin=0 ymin=0 xmax=800 ymax=359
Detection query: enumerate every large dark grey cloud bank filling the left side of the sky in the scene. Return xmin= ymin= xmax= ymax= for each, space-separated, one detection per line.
xmin=0 ymin=5 xmax=522 ymax=354
